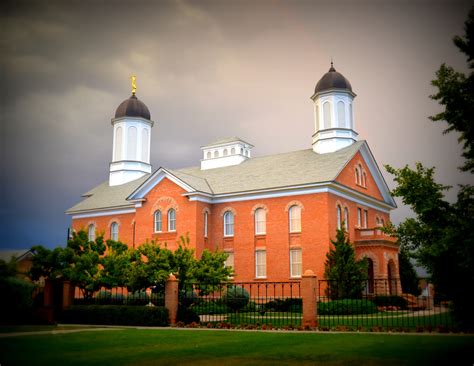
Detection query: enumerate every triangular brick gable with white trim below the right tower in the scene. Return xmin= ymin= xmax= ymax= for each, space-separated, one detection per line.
xmin=336 ymin=143 xmax=397 ymax=208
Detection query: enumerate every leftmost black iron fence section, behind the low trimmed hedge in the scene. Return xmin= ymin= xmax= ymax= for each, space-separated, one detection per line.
xmin=73 ymin=287 xmax=165 ymax=306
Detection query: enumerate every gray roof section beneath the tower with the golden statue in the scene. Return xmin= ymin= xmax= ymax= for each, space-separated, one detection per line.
xmin=66 ymin=174 xmax=150 ymax=214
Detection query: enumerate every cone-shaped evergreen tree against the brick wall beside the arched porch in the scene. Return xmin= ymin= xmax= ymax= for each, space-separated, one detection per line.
xmin=324 ymin=228 xmax=368 ymax=300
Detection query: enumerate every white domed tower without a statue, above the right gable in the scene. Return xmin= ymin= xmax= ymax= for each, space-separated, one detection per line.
xmin=311 ymin=61 xmax=357 ymax=154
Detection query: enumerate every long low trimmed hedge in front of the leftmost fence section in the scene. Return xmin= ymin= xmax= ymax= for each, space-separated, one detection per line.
xmin=60 ymin=305 xmax=169 ymax=326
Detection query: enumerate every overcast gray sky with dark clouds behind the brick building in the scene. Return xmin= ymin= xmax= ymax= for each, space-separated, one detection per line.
xmin=0 ymin=0 xmax=473 ymax=248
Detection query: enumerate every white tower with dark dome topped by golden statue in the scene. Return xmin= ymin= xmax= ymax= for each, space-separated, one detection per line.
xmin=109 ymin=76 xmax=154 ymax=186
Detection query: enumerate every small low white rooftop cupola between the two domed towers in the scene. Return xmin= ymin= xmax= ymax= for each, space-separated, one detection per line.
xmin=201 ymin=137 xmax=253 ymax=170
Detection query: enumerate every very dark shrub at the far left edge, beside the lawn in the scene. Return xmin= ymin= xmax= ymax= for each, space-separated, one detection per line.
xmin=0 ymin=277 xmax=35 ymax=324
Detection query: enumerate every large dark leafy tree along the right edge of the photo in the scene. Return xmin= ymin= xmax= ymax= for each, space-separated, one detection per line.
xmin=386 ymin=8 xmax=474 ymax=329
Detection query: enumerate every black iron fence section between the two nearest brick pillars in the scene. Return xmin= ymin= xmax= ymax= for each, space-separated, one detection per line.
xmin=179 ymin=281 xmax=302 ymax=328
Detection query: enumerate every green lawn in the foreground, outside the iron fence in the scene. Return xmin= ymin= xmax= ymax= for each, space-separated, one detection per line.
xmin=0 ymin=329 xmax=474 ymax=366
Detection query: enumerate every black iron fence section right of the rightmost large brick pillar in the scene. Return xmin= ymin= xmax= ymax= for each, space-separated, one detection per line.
xmin=318 ymin=279 xmax=456 ymax=332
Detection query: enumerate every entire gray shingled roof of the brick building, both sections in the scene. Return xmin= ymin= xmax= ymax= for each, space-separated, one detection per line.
xmin=66 ymin=141 xmax=365 ymax=214
